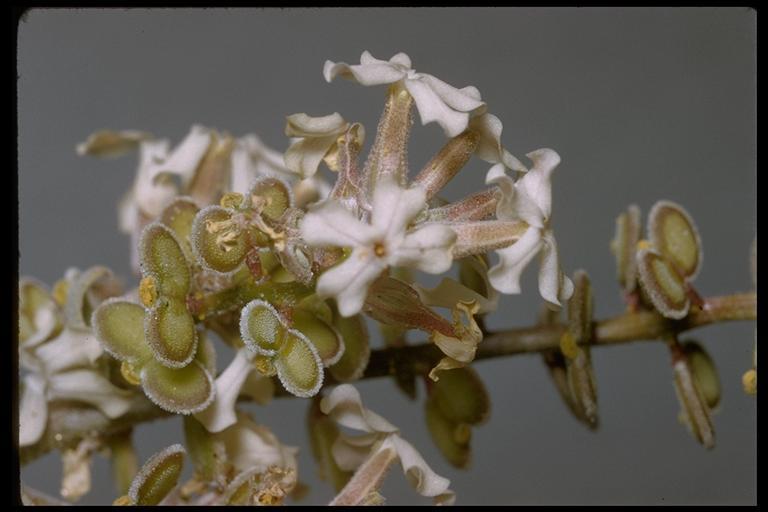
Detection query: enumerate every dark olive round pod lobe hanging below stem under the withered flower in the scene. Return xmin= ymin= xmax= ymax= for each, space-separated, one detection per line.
xmin=430 ymin=366 xmax=491 ymax=425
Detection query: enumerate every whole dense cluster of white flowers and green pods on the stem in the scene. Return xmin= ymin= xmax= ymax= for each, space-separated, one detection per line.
xmin=20 ymin=52 xmax=574 ymax=505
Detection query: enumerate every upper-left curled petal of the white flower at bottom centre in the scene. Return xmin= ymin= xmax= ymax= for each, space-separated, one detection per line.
xmin=320 ymin=384 xmax=398 ymax=434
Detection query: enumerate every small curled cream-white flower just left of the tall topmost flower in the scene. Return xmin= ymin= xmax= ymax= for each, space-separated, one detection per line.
xmin=285 ymin=112 xmax=349 ymax=178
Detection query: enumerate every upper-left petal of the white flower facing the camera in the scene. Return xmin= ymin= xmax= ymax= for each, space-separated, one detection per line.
xmin=300 ymin=201 xmax=375 ymax=247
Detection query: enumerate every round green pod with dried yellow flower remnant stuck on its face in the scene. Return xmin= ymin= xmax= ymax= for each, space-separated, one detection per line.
xmin=190 ymin=205 xmax=249 ymax=273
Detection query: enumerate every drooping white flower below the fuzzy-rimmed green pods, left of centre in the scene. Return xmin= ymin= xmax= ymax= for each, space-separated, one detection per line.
xmin=194 ymin=348 xmax=273 ymax=433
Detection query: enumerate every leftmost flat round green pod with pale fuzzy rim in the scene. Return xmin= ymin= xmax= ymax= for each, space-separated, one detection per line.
xmin=91 ymin=298 xmax=152 ymax=366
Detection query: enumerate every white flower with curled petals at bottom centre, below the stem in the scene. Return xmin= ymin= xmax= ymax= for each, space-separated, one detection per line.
xmin=320 ymin=384 xmax=455 ymax=505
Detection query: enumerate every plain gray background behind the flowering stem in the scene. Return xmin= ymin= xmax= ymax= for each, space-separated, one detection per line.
xmin=18 ymin=8 xmax=756 ymax=504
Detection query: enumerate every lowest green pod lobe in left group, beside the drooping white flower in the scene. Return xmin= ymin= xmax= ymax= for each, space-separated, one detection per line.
xmin=141 ymin=360 xmax=215 ymax=414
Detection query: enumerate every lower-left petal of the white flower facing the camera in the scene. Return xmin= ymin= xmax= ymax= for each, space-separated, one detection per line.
xmin=316 ymin=248 xmax=386 ymax=317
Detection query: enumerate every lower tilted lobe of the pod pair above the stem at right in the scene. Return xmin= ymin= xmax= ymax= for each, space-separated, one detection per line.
xmin=637 ymin=249 xmax=690 ymax=319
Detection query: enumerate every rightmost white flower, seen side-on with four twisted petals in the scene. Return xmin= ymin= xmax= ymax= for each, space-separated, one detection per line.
xmin=486 ymin=149 xmax=573 ymax=306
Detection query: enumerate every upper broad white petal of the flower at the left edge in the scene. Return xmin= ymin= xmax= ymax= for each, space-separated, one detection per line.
xmin=35 ymin=328 xmax=103 ymax=375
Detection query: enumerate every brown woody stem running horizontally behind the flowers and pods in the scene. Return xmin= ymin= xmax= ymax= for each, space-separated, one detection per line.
xmin=20 ymin=292 xmax=757 ymax=464
